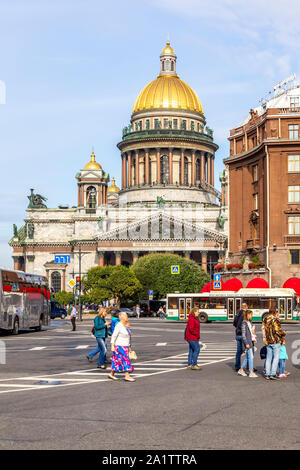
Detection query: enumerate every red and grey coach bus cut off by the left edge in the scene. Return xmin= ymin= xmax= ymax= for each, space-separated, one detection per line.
xmin=0 ymin=268 xmax=50 ymax=335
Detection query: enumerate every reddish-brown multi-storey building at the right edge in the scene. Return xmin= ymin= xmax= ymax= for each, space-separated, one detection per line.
xmin=224 ymin=77 xmax=300 ymax=287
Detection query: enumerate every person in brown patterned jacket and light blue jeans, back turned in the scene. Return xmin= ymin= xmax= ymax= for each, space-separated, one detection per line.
xmin=262 ymin=308 xmax=286 ymax=380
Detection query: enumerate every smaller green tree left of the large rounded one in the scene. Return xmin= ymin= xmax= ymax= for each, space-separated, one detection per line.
xmin=84 ymin=265 xmax=141 ymax=303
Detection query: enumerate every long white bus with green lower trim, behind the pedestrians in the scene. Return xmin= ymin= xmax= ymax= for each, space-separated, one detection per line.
xmin=167 ymin=288 xmax=300 ymax=323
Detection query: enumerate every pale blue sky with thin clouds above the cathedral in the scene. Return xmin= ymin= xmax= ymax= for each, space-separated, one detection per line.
xmin=0 ymin=0 xmax=300 ymax=267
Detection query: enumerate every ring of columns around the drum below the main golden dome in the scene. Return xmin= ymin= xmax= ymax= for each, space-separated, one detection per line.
xmin=122 ymin=147 xmax=214 ymax=189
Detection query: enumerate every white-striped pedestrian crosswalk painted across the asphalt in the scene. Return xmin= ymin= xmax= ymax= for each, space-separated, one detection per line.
xmin=0 ymin=342 xmax=236 ymax=394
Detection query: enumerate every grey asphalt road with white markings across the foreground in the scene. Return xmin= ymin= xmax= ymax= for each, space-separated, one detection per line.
xmin=0 ymin=319 xmax=300 ymax=450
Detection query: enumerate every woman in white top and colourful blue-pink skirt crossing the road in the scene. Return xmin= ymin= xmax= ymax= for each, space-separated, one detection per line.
xmin=108 ymin=312 xmax=135 ymax=382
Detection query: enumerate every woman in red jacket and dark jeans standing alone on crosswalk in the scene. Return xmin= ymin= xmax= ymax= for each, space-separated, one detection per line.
xmin=184 ymin=308 xmax=201 ymax=370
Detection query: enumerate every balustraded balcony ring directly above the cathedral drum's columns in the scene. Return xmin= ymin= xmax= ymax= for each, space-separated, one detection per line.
xmin=119 ymin=127 xmax=213 ymax=142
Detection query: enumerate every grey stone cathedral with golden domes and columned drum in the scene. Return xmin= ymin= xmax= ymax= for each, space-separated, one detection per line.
xmin=9 ymin=41 xmax=228 ymax=291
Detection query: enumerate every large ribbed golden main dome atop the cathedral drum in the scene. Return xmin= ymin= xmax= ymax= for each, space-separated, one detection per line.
xmin=132 ymin=76 xmax=203 ymax=114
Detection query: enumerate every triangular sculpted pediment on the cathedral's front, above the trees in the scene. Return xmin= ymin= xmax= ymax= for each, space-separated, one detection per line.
xmin=95 ymin=211 xmax=227 ymax=243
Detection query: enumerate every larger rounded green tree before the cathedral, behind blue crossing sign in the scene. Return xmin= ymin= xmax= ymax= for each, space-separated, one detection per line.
xmin=131 ymin=254 xmax=209 ymax=299
